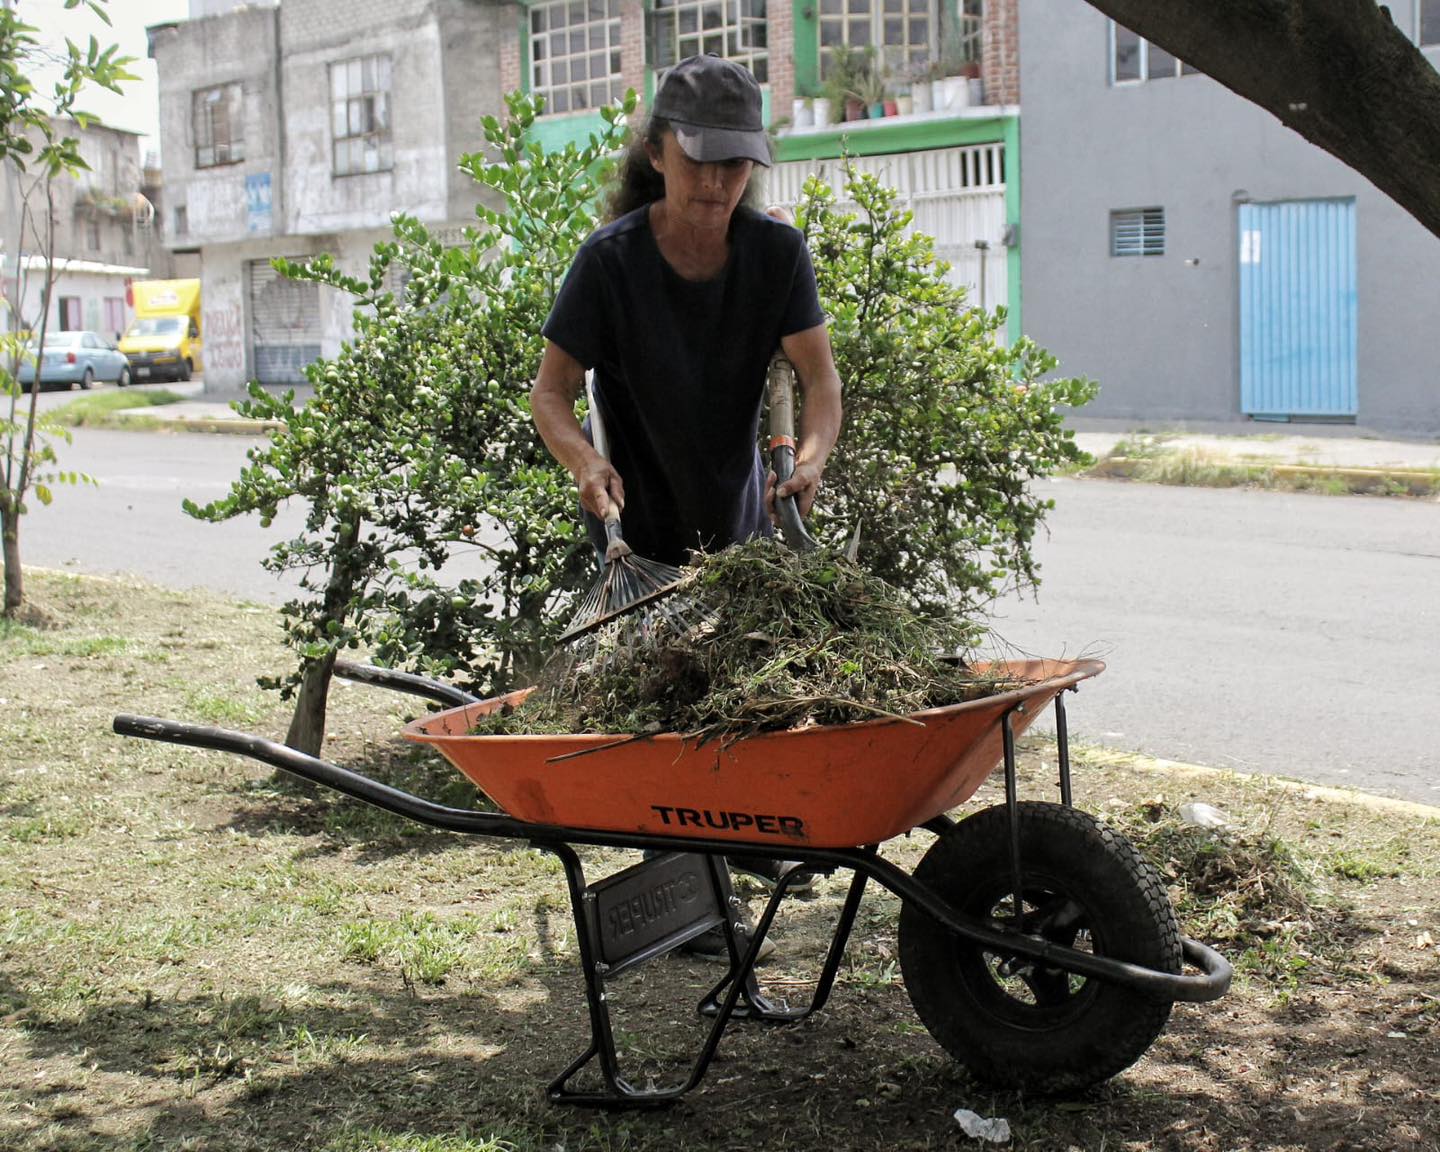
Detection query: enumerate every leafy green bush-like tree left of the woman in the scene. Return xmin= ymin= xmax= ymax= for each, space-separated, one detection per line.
xmin=186 ymin=94 xmax=635 ymax=753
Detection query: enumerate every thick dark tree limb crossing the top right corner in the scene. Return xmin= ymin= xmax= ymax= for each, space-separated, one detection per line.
xmin=1090 ymin=0 xmax=1440 ymax=236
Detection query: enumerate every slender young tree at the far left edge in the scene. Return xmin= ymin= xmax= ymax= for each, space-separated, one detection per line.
xmin=0 ymin=0 xmax=135 ymax=616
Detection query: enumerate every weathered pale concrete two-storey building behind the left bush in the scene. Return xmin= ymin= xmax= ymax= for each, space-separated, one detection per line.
xmin=150 ymin=0 xmax=501 ymax=392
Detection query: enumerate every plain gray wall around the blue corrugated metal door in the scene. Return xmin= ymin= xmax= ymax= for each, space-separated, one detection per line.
xmin=1020 ymin=0 xmax=1440 ymax=435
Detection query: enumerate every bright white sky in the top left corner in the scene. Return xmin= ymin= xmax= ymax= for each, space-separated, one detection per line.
xmin=22 ymin=0 xmax=190 ymax=163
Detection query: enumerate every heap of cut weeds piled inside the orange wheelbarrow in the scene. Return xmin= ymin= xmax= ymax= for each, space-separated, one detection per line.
xmin=478 ymin=540 xmax=1015 ymax=740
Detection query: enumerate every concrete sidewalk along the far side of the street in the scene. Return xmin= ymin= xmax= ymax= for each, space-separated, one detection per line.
xmin=123 ymin=382 xmax=1440 ymax=472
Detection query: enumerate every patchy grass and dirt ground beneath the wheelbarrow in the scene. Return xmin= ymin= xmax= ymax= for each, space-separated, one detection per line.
xmin=0 ymin=573 xmax=1440 ymax=1152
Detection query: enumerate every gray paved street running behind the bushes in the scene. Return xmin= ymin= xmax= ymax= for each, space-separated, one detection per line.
xmin=22 ymin=417 xmax=1440 ymax=804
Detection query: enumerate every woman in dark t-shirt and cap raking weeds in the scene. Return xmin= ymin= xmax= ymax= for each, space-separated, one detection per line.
xmin=530 ymin=56 xmax=841 ymax=956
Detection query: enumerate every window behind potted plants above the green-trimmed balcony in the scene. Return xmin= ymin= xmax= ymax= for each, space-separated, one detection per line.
xmin=819 ymin=0 xmax=956 ymax=82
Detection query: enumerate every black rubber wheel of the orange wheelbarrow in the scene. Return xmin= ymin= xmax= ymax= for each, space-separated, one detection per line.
xmin=900 ymin=802 xmax=1181 ymax=1094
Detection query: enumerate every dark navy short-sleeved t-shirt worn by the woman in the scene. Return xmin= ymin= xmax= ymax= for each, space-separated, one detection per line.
xmin=544 ymin=207 xmax=825 ymax=564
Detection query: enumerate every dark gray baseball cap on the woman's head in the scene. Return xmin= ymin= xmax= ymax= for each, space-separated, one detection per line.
xmin=652 ymin=55 xmax=770 ymax=167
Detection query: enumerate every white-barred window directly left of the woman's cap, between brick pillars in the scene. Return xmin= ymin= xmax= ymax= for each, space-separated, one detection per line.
xmin=530 ymin=0 xmax=625 ymax=112
